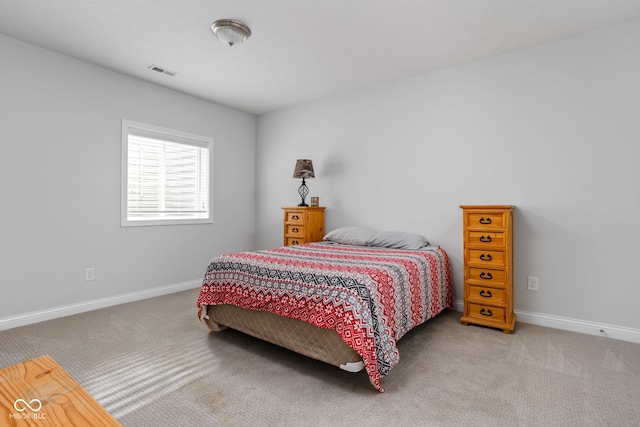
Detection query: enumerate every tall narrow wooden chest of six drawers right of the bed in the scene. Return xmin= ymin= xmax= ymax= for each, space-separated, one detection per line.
xmin=460 ymin=205 xmax=516 ymax=334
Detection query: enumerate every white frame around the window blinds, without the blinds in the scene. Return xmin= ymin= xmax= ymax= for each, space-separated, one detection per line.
xmin=120 ymin=119 xmax=213 ymax=227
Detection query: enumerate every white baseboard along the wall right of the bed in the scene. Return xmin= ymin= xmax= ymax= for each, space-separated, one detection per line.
xmin=454 ymin=300 xmax=640 ymax=344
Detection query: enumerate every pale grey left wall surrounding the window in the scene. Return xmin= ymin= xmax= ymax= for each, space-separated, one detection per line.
xmin=0 ymin=36 xmax=256 ymax=326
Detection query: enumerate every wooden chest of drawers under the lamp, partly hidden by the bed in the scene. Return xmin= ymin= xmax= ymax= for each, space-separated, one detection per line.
xmin=282 ymin=206 xmax=324 ymax=246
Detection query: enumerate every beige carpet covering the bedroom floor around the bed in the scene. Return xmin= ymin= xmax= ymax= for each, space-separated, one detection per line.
xmin=0 ymin=290 xmax=640 ymax=426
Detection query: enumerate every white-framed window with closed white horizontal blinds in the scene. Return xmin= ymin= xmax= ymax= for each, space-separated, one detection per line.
xmin=121 ymin=120 xmax=213 ymax=226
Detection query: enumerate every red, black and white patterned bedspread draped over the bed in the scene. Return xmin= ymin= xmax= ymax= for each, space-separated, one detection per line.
xmin=197 ymin=242 xmax=453 ymax=392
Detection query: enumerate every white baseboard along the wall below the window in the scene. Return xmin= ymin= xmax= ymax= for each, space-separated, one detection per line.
xmin=0 ymin=279 xmax=202 ymax=331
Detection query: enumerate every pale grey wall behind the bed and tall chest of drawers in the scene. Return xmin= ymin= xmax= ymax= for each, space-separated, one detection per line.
xmin=257 ymin=21 xmax=640 ymax=330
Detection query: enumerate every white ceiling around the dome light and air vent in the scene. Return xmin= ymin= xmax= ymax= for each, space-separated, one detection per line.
xmin=0 ymin=0 xmax=640 ymax=114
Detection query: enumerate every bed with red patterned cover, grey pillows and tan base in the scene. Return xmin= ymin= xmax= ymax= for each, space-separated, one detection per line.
xmin=196 ymin=228 xmax=453 ymax=392
